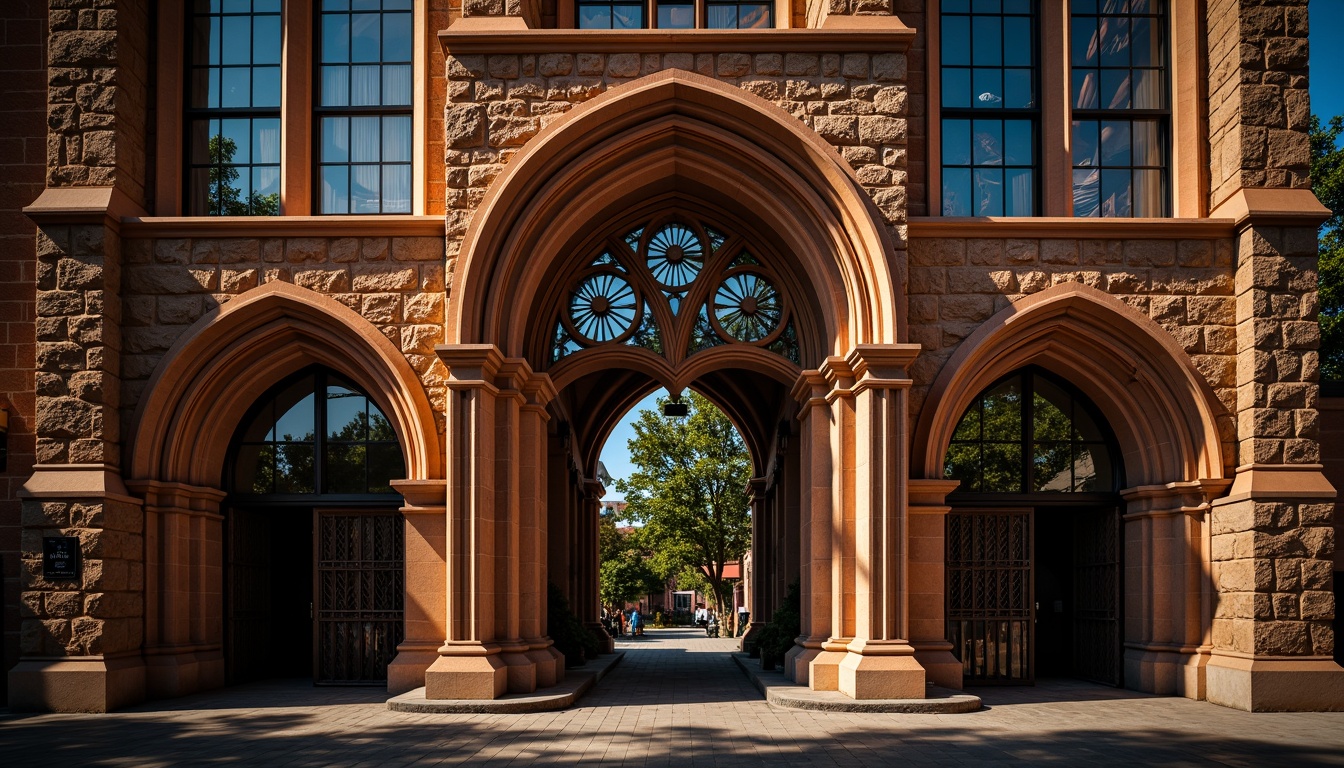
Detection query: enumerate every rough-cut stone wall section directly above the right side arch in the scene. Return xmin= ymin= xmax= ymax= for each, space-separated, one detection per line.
xmin=909 ymin=238 xmax=1236 ymax=427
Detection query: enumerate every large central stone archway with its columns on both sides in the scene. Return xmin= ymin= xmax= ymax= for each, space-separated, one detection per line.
xmin=426 ymin=70 xmax=925 ymax=698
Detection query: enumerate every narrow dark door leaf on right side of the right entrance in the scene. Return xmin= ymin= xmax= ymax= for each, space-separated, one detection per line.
xmin=1074 ymin=508 xmax=1121 ymax=686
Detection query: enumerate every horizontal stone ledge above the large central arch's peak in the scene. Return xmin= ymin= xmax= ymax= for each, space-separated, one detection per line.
xmin=438 ymin=25 xmax=915 ymax=56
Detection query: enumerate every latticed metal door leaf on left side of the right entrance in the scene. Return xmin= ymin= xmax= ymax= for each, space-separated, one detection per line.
xmin=948 ymin=510 xmax=1034 ymax=685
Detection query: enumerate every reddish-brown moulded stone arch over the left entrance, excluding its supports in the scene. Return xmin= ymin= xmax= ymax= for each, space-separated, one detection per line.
xmin=129 ymin=281 xmax=442 ymax=487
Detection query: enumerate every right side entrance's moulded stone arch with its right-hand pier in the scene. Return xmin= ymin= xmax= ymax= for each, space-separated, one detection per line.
xmin=911 ymin=282 xmax=1232 ymax=698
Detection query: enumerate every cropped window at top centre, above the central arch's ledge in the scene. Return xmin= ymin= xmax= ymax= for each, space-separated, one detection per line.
xmin=578 ymin=0 xmax=774 ymax=30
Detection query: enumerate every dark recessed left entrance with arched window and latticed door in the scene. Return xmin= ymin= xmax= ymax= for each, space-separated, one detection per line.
xmin=224 ymin=369 xmax=405 ymax=685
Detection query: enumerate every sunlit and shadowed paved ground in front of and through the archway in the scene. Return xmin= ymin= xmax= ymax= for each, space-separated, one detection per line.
xmin=0 ymin=629 xmax=1344 ymax=767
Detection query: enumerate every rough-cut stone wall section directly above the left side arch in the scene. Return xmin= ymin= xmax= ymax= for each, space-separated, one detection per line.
xmin=122 ymin=237 xmax=444 ymax=429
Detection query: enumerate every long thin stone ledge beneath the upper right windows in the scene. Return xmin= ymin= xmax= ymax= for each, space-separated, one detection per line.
xmin=907 ymin=217 xmax=1236 ymax=239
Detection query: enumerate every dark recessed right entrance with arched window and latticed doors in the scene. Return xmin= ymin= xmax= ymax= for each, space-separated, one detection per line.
xmin=946 ymin=369 xmax=1122 ymax=686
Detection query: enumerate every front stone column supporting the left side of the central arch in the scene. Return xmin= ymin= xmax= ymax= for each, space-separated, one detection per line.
xmin=425 ymin=344 xmax=508 ymax=699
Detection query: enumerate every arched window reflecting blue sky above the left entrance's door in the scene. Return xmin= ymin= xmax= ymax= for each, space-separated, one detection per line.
xmin=230 ymin=370 xmax=406 ymax=496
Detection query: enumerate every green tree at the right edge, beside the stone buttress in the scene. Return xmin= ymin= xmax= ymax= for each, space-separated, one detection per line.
xmin=1312 ymin=114 xmax=1344 ymax=381
